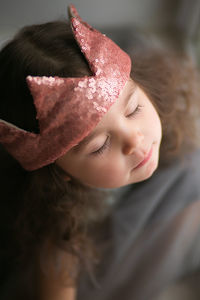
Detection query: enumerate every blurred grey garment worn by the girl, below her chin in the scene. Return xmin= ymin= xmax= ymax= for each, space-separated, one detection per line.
xmin=77 ymin=151 xmax=200 ymax=300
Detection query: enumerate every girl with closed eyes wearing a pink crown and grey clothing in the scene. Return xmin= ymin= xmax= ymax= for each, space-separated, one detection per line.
xmin=0 ymin=6 xmax=200 ymax=300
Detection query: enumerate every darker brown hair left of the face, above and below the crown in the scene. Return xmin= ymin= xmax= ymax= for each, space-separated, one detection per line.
xmin=0 ymin=21 xmax=108 ymax=299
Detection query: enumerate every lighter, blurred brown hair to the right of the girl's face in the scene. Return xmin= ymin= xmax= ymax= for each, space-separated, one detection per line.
xmin=132 ymin=49 xmax=200 ymax=167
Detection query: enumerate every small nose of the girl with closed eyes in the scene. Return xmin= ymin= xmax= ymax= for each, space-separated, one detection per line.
xmin=122 ymin=129 xmax=144 ymax=155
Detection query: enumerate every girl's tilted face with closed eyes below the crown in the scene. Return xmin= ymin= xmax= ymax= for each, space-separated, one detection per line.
xmin=56 ymin=79 xmax=162 ymax=188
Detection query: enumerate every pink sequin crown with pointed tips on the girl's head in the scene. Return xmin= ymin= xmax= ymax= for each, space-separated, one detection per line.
xmin=0 ymin=5 xmax=131 ymax=170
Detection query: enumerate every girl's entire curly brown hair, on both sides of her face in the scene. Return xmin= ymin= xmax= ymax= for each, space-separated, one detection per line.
xmin=0 ymin=21 xmax=199 ymax=299
